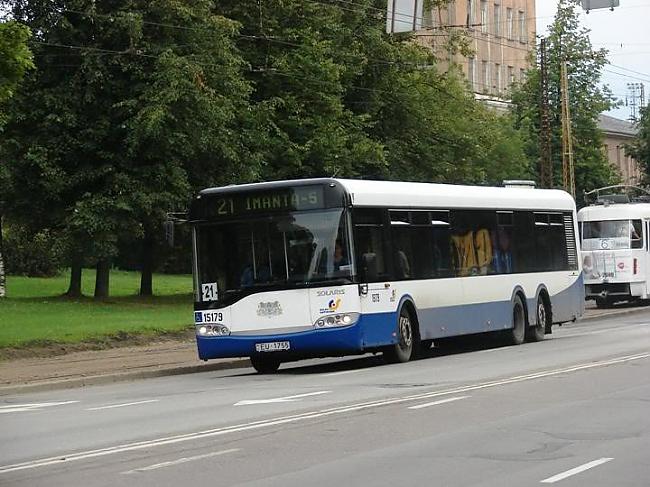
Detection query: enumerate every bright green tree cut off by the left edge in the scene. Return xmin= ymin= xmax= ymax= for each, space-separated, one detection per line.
xmin=0 ymin=21 xmax=34 ymax=298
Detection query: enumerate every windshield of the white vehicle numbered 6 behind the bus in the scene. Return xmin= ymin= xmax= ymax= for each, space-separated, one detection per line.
xmin=582 ymin=220 xmax=643 ymax=250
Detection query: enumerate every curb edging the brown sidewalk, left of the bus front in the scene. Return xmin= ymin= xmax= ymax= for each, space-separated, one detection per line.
xmin=0 ymin=359 xmax=251 ymax=396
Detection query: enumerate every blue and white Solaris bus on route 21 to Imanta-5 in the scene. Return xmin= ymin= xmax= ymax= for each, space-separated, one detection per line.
xmin=189 ymin=178 xmax=584 ymax=373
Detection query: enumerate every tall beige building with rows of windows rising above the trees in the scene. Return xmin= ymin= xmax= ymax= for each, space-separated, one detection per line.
xmin=416 ymin=0 xmax=535 ymax=99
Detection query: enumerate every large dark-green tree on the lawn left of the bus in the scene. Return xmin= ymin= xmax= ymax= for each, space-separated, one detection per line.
xmin=4 ymin=0 xmax=263 ymax=297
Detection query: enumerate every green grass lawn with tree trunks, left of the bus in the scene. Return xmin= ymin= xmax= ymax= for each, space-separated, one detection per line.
xmin=0 ymin=269 xmax=192 ymax=348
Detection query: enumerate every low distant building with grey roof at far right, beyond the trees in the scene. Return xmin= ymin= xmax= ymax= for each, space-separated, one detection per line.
xmin=598 ymin=115 xmax=642 ymax=186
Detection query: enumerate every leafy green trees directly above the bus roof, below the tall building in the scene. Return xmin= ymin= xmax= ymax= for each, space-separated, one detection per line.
xmin=219 ymin=0 xmax=528 ymax=183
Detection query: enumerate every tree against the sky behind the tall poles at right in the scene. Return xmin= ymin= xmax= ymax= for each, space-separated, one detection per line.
xmin=513 ymin=0 xmax=619 ymax=202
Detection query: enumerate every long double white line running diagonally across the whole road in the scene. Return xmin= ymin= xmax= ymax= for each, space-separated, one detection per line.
xmin=0 ymin=353 xmax=650 ymax=474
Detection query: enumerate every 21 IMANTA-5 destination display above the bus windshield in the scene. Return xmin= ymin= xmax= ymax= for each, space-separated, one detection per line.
xmin=209 ymin=186 xmax=324 ymax=218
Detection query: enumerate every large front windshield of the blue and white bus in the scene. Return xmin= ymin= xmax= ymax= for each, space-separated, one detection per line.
xmin=196 ymin=208 xmax=352 ymax=301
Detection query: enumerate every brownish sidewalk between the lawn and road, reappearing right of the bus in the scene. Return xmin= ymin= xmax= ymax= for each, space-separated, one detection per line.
xmin=0 ymin=303 xmax=650 ymax=396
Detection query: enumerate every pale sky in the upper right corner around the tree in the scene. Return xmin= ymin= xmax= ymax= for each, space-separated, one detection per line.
xmin=535 ymin=0 xmax=650 ymax=120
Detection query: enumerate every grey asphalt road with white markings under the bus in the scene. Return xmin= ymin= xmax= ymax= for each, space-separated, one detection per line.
xmin=0 ymin=310 xmax=650 ymax=487
